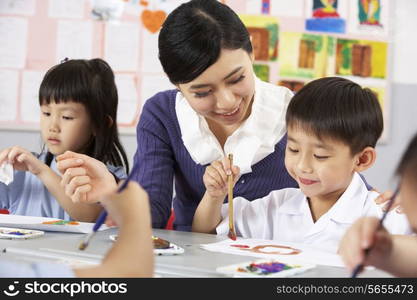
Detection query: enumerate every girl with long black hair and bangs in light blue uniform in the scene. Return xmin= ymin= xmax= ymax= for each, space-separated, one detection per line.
xmin=0 ymin=59 xmax=128 ymax=222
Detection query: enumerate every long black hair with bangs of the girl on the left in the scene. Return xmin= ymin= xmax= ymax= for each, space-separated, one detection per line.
xmin=39 ymin=58 xmax=129 ymax=173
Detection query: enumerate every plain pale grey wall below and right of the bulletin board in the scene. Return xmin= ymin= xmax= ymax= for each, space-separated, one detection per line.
xmin=0 ymin=0 xmax=417 ymax=191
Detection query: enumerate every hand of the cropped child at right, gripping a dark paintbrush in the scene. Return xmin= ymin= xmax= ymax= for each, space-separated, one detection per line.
xmin=339 ymin=217 xmax=392 ymax=271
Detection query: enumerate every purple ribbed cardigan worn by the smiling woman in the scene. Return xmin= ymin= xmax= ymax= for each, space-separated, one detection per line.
xmin=133 ymin=90 xmax=298 ymax=231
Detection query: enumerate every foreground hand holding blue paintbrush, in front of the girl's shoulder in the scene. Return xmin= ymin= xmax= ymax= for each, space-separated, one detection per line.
xmin=57 ymin=151 xmax=117 ymax=203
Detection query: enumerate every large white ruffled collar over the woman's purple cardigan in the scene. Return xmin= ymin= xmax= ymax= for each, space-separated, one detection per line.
xmin=175 ymin=78 xmax=293 ymax=175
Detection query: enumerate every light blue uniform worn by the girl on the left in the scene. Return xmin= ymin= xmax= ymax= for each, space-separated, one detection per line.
xmin=0 ymin=153 xmax=126 ymax=221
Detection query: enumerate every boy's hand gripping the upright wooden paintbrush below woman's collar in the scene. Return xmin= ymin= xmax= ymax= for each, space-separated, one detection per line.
xmin=203 ymin=157 xmax=240 ymax=200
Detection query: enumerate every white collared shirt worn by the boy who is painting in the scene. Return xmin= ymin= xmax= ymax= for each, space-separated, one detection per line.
xmin=216 ymin=173 xmax=412 ymax=252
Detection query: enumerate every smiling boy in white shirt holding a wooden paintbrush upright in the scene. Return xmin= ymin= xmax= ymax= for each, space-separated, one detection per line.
xmin=193 ymin=77 xmax=409 ymax=252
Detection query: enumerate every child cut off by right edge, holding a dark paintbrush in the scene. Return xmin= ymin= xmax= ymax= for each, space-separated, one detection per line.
xmin=340 ymin=135 xmax=417 ymax=277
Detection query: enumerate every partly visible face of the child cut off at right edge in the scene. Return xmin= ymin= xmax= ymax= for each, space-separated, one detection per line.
xmin=400 ymin=175 xmax=417 ymax=232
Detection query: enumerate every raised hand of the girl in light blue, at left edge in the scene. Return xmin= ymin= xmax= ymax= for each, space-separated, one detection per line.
xmin=0 ymin=146 xmax=46 ymax=175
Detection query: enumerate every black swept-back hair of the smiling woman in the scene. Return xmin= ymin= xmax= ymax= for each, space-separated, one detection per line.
xmin=158 ymin=0 xmax=252 ymax=84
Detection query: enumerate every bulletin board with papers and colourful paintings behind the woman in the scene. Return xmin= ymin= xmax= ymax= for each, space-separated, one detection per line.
xmin=0 ymin=0 xmax=392 ymax=140
